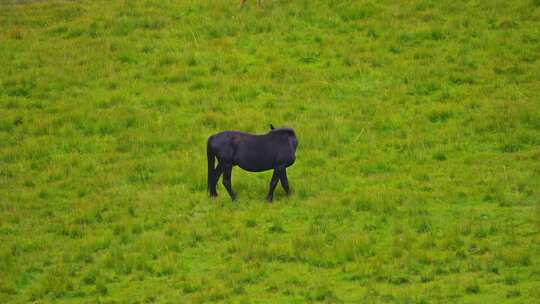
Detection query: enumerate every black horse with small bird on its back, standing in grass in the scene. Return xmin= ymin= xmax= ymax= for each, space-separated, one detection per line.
xmin=206 ymin=125 xmax=298 ymax=202
